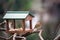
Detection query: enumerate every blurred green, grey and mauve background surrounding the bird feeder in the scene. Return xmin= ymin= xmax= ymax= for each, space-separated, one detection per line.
xmin=0 ymin=0 xmax=60 ymax=40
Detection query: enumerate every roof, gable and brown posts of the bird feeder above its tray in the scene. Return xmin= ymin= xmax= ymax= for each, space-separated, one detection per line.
xmin=3 ymin=11 xmax=34 ymax=31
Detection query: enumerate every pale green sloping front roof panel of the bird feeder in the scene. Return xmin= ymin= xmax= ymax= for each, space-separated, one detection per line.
xmin=3 ymin=11 xmax=29 ymax=19
